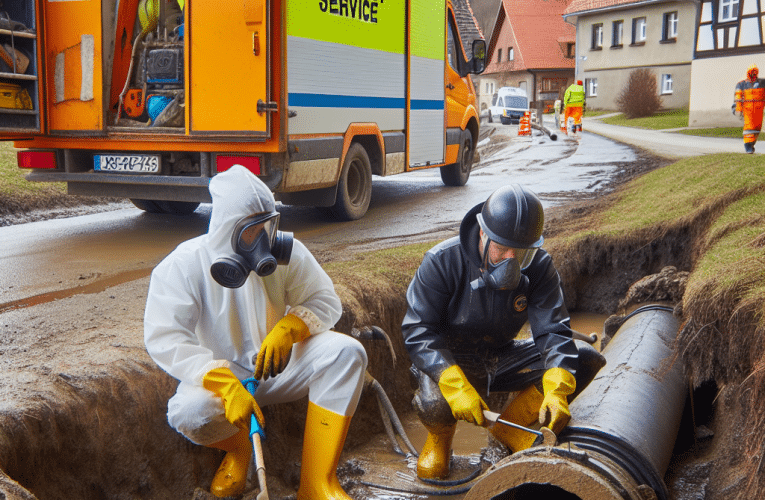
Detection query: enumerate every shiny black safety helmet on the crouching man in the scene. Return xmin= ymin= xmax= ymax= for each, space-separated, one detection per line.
xmin=476 ymin=184 xmax=545 ymax=248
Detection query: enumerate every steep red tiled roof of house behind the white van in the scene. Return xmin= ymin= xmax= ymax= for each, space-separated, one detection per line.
xmin=492 ymin=0 xmax=576 ymax=71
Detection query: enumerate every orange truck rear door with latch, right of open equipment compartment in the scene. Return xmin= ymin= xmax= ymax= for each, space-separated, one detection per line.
xmin=186 ymin=0 xmax=271 ymax=139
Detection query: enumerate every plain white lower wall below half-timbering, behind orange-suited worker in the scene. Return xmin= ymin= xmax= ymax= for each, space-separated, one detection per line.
xmin=688 ymin=54 xmax=765 ymax=127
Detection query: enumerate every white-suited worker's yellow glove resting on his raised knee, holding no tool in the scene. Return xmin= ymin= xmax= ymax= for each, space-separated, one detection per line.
xmin=255 ymin=314 xmax=311 ymax=380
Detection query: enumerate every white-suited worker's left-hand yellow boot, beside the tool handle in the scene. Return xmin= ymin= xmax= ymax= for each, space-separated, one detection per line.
xmin=210 ymin=429 xmax=252 ymax=498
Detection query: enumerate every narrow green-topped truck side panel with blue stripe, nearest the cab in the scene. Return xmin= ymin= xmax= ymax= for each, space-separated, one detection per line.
xmin=407 ymin=0 xmax=446 ymax=167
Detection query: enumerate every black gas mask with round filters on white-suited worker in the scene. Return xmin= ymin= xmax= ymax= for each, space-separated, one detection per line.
xmin=210 ymin=212 xmax=293 ymax=288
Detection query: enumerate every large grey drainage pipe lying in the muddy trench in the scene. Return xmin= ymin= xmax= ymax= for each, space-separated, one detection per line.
xmin=465 ymin=305 xmax=687 ymax=500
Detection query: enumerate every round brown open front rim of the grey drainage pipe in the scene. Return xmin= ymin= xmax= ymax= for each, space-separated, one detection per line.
xmin=464 ymin=447 xmax=653 ymax=500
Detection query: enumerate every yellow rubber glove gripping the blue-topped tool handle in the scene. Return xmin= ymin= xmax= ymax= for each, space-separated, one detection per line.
xmin=202 ymin=368 xmax=265 ymax=429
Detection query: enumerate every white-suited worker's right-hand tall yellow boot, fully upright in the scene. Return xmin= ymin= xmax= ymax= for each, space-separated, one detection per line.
xmin=297 ymin=401 xmax=351 ymax=500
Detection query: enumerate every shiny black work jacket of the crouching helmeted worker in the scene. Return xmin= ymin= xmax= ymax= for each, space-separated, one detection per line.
xmin=401 ymin=223 xmax=579 ymax=383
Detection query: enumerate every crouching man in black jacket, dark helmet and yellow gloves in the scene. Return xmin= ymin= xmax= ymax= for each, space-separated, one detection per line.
xmin=402 ymin=185 xmax=605 ymax=479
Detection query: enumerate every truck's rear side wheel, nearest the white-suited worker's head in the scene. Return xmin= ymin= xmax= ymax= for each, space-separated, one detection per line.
xmin=331 ymin=143 xmax=372 ymax=220
